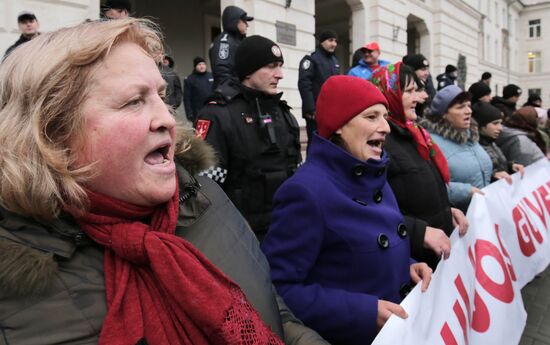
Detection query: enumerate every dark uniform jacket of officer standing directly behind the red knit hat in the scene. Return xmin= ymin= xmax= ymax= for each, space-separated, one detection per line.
xmin=298 ymin=46 xmax=340 ymax=115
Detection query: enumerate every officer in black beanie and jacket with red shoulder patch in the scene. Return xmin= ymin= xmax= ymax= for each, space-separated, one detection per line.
xmin=195 ymin=36 xmax=302 ymax=240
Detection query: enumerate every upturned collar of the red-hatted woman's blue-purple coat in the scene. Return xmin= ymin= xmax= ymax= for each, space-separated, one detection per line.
xmin=306 ymin=133 xmax=389 ymax=191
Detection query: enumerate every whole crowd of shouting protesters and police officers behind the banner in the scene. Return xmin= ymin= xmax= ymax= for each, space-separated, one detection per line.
xmin=0 ymin=0 xmax=550 ymax=345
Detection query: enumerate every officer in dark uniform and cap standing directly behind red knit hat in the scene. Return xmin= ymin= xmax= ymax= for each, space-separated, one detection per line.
xmin=298 ymin=30 xmax=340 ymax=147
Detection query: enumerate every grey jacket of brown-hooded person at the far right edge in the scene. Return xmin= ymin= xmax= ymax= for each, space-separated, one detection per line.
xmin=496 ymin=126 xmax=545 ymax=166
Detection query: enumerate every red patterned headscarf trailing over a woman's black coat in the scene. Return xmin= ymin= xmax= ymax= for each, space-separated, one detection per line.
xmin=371 ymin=62 xmax=450 ymax=183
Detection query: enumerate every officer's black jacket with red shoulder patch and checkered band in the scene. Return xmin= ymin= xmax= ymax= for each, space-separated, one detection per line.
xmin=196 ymin=82 xmax=302 ymax=238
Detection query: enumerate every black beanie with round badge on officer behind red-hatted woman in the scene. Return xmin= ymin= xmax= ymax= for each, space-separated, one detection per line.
xmin=235 ymin=35 xmax=284 ymax=81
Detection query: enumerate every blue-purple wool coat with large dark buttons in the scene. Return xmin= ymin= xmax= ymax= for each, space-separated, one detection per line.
xmin=262 ymin=134 xmax=412 ymax=344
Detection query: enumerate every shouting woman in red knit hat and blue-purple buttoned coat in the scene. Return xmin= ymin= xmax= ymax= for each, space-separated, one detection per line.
xmin=263 ymin=76 xmax=431 ymax=344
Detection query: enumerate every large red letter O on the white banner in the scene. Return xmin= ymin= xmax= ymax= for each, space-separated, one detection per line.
xmin=468 ymin=239 xmax=514 ymax=303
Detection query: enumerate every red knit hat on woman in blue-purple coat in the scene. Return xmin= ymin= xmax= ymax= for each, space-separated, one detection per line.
xmin=315 ymin=75 xmax=388 ymax=139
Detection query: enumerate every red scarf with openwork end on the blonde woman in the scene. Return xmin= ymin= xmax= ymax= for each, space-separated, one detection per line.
xmin=73 ymin=181 xmax=283 ymax=345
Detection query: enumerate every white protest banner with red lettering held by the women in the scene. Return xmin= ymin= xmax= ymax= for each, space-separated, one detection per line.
xmin=373 ymin=160 xmax=550 ymax=345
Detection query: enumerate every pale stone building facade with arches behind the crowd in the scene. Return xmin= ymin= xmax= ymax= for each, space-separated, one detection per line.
xmin=0 ymin=0 xmax=550 ymax=114
